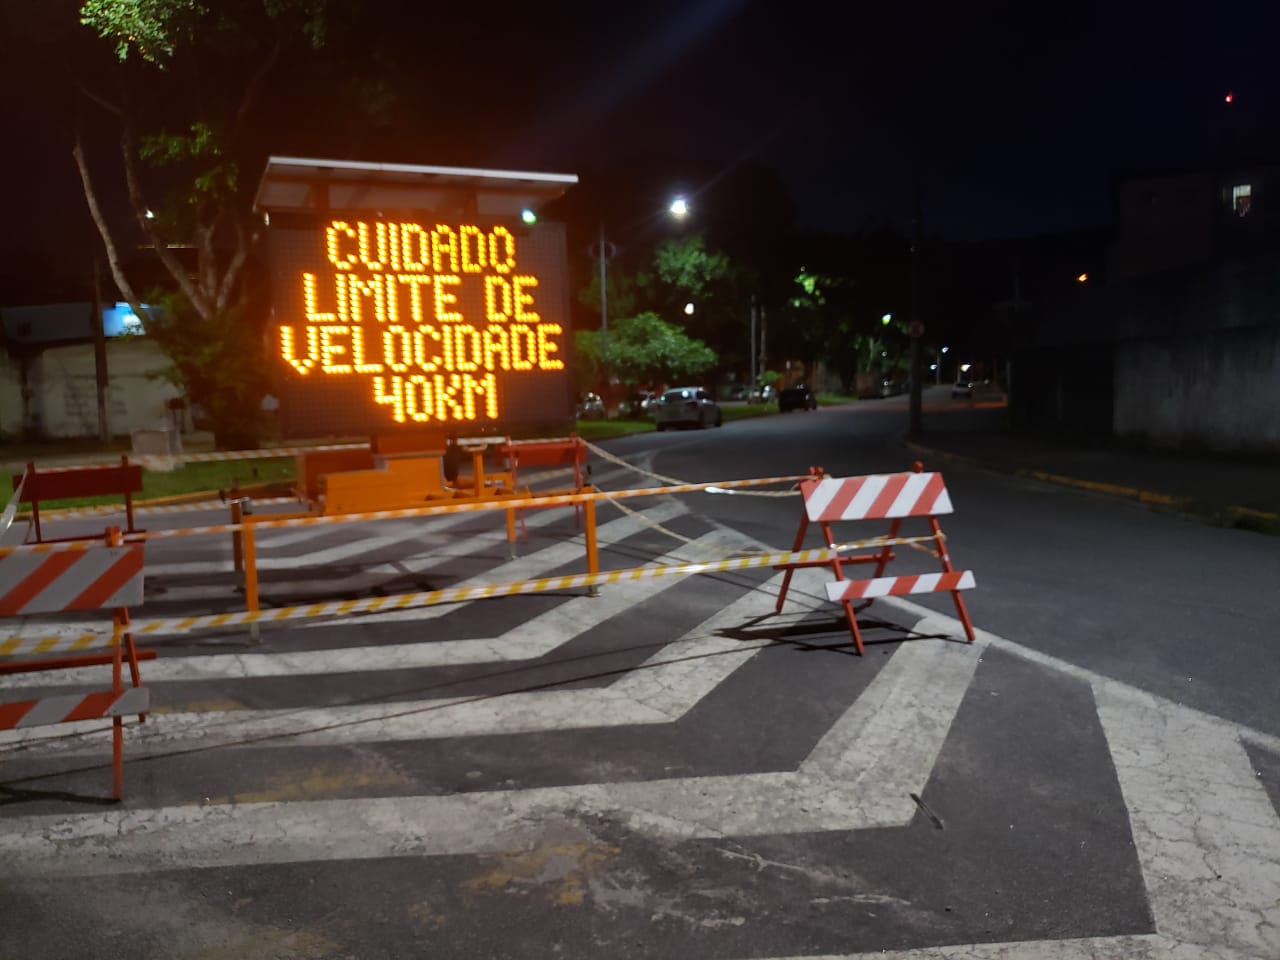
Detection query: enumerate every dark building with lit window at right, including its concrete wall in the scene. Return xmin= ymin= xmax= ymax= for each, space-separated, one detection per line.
xmin=1012 ymin=164 xmax=1280 ymax=454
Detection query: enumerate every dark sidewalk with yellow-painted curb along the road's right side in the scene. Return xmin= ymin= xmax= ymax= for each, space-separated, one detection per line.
xmin=906 ymin=420 xmax=1280 ymax=535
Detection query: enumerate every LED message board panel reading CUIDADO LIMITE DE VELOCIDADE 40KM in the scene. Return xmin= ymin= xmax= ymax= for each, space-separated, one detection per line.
xmin=269 ymin=211 xmax=573 ymax=436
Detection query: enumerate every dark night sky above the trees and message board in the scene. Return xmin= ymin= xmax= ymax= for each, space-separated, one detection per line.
xmin=0 ymin=0 xmax=1280 ymax=295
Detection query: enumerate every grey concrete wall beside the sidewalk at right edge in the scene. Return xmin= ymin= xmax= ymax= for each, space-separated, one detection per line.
xmin=1115 ymin=328 xmax=1280 ymax=454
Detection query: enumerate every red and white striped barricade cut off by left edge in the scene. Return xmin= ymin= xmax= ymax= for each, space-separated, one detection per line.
xmin=0 ymin=527 xmax=155 ymax=800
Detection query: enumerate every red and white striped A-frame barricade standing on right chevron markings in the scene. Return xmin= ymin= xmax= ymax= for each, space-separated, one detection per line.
xmin=776 ymin=462 xmax=974 ymax=654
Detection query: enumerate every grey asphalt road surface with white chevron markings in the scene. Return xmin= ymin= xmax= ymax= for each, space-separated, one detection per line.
xmin=0 ymin=398 xmax=1280 ymax=960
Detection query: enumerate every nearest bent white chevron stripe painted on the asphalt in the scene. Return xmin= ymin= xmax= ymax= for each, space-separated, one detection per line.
xmin=0 ymin=624 xmax=978 ymax=877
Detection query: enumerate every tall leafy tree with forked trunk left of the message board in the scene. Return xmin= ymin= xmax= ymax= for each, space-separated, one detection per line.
xmin=73 ymin=0 xmax=328 ymax=445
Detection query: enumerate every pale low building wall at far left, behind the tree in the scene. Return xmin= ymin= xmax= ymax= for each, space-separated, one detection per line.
xmin=0 ymin=338 xmax=179 ymax=436
